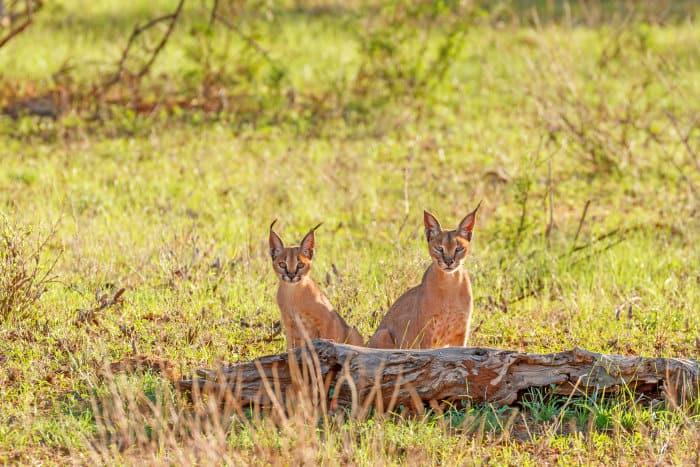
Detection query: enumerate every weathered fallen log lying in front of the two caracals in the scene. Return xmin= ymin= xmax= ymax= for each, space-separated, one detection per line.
xmin=179 ymin=340 xmax=700 ymax=408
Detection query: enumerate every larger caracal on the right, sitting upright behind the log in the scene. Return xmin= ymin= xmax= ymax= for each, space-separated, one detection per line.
xmin=369 ymin=203 xmax=481 ymax=349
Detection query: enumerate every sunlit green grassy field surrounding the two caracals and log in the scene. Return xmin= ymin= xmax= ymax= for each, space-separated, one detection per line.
xmin=0 ymin=0 xmax=700 ymax=465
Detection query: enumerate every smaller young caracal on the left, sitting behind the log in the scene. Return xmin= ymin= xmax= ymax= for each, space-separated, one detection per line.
xmin=270 ymin=222 xmax=364 ymax=348
